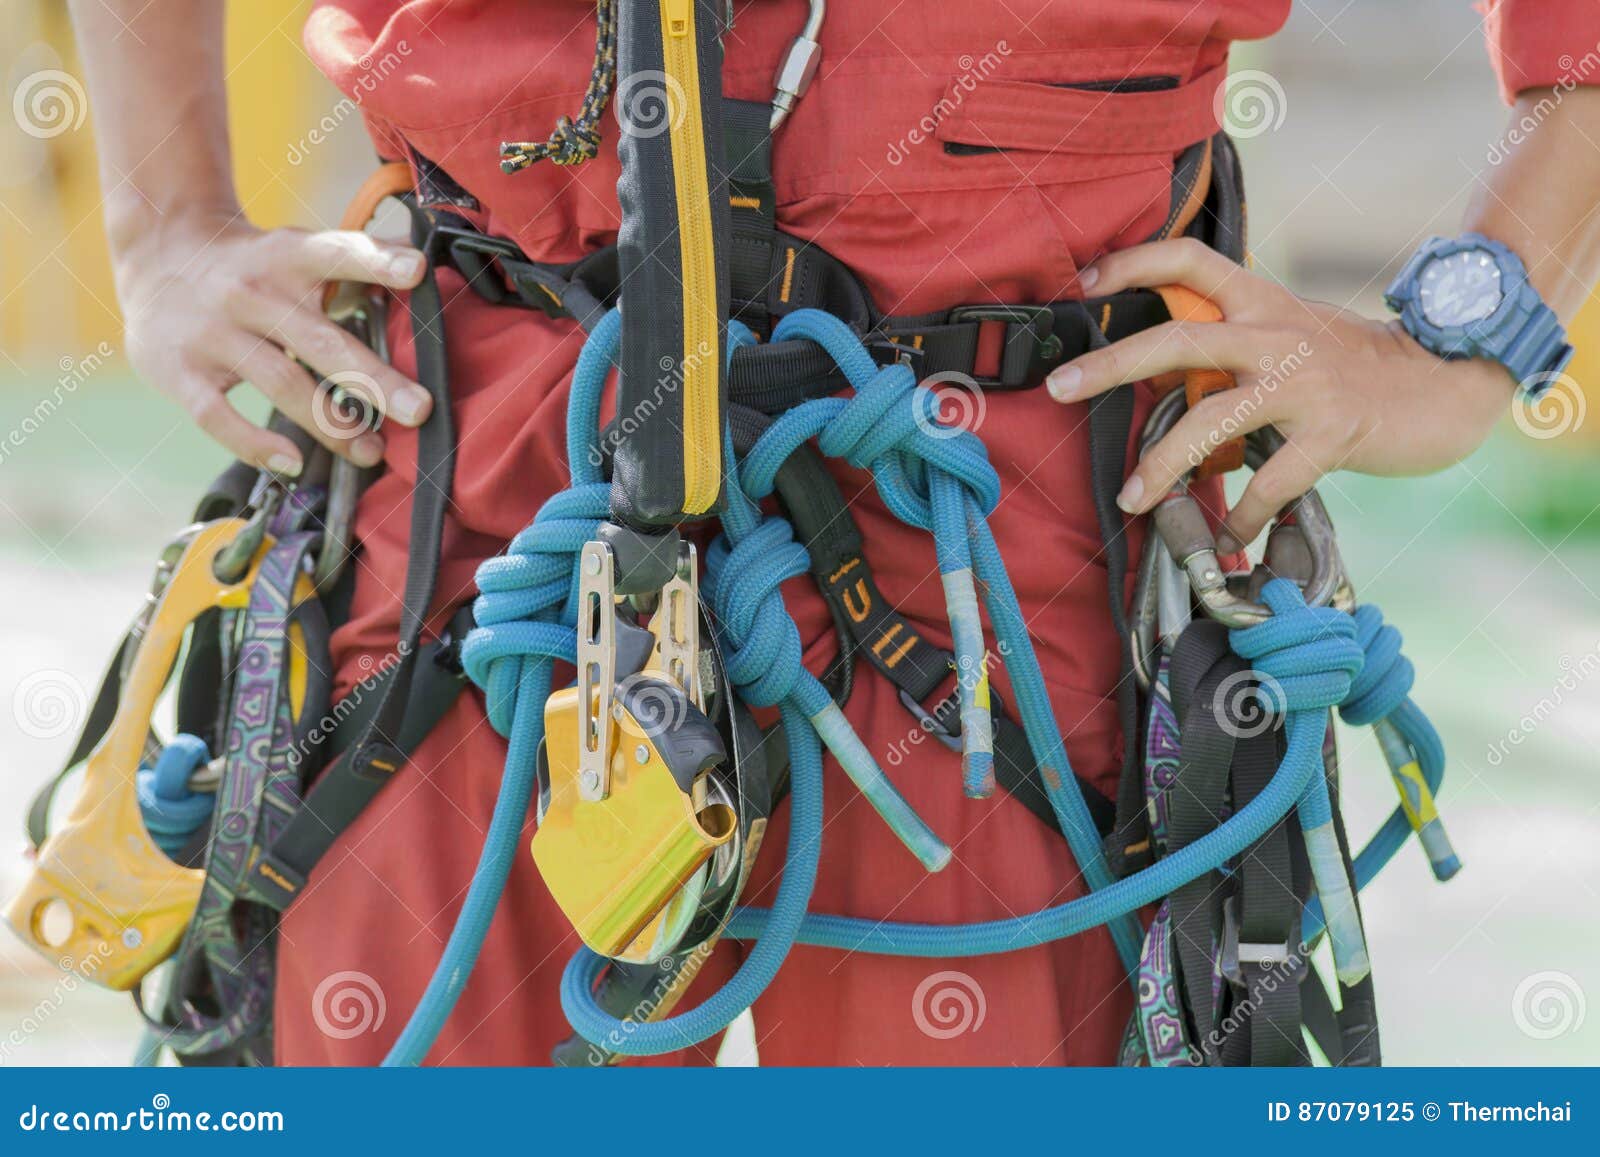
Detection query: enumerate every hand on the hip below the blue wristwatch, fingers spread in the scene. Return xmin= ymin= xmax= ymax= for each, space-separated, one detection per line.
xmin=1048 ymin=238 xmax=1514 ymax=552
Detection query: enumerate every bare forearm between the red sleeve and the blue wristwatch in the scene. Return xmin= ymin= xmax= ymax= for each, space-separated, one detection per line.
xmin=1464 ymin=88 xmax=1600 ymax=323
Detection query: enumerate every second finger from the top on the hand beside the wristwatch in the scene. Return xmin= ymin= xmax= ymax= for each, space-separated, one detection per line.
xmin=1045 ymin=322 xmax=1296 ymax=402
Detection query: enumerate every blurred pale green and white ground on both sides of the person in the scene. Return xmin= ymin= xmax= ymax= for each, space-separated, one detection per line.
xmin=0 ymin=366 xmax=1600 ymax=1064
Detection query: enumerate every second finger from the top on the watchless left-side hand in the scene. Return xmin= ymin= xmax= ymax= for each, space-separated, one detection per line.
xmin=232 ymin=294 xmax=432 ymax=426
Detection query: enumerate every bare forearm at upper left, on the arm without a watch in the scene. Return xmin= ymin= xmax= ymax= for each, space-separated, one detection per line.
xmin=70 ymin=0 xmax=238 ymax=251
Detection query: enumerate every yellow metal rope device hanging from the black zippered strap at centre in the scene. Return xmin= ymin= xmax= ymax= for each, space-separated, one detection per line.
xmin=533 ymin=541 xmax=738 ymax=960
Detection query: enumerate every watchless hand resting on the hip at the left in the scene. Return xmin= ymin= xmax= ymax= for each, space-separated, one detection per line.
xmin=114 ymin=216 xmax=430 ymax=475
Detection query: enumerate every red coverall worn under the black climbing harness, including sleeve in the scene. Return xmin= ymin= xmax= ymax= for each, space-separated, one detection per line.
xmin=277 ymin=0 xmax=1600 ymax=1064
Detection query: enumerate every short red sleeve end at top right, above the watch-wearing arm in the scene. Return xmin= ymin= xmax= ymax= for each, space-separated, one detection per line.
xmin=1478 ymin=0 xmax=1600 ymax=104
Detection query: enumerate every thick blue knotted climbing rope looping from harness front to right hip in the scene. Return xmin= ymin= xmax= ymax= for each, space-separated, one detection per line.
xmin=386 ymin=302 xmax=1443 ymax=1064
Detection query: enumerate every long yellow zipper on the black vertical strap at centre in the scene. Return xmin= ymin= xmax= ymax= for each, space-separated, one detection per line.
xmin=661 ymin=0 xmax=722 ymax=514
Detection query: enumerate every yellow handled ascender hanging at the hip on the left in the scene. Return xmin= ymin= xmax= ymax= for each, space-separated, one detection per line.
xmin=5 ymin=518 xmax=300 ymax=991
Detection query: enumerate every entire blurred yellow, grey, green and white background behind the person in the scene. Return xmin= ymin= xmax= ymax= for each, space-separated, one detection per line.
xmin=0 ymin=0 xmax=1600 ymax=1066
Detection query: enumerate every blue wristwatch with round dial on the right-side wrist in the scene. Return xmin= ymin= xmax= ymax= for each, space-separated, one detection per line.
xmin=1384 ymin=234 xmax=1573 ymax=397
